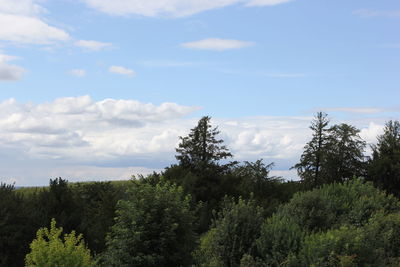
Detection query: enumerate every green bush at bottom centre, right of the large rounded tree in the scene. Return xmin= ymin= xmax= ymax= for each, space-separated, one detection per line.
xmin=197 ymin=198 xmax=263 ymax=267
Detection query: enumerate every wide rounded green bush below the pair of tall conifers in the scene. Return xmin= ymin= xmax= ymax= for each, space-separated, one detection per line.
xmin=277 ymin=180 xmax=400 ymax=231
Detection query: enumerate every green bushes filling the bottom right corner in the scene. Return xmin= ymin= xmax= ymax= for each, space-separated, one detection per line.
xmin=292 ymin=213 xmax=400 ymax=266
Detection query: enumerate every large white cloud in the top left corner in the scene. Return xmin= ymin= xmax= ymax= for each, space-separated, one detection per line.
xmin=0 ymin=0 xmax=70 ymax=44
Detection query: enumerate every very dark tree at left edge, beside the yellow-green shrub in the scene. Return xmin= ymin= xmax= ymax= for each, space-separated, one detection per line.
xmin=0 ymin=183 xmax=35 ymax=267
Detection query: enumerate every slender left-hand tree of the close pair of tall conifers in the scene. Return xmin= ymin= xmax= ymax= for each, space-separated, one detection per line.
xmin=292 ymin=112 xmax=329 ymax=188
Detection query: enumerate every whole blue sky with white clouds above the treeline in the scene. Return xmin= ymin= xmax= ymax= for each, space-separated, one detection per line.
xmin=0 ymin=0 xmax=400 ymax=186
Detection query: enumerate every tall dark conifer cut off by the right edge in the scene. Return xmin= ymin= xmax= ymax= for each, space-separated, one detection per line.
xmin=368 ymin=121 xmax=400 ymax=197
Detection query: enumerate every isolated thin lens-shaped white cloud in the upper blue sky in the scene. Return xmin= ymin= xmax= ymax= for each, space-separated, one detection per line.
xmin=181 ymin=38 xmax=254 ymax=51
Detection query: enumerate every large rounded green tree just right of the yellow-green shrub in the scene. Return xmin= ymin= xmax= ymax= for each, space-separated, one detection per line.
xmin=102 ymin=182 xmax=196 ymax=267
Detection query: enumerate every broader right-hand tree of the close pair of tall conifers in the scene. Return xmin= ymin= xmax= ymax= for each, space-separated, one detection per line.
xmin=322 ymin=123 xmax=366 ymax=183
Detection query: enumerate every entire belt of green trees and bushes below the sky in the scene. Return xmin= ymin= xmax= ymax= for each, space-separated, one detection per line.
xmin=0 ymin=112 xmax=400 ymax=267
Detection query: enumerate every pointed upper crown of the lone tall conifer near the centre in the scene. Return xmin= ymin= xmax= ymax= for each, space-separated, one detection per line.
xmin=176 ymin=116 xmax=232 ymax=169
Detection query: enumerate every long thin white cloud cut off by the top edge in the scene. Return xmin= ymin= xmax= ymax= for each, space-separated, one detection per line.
xmin=83 ymin=0 xmax=289 ymax=17
